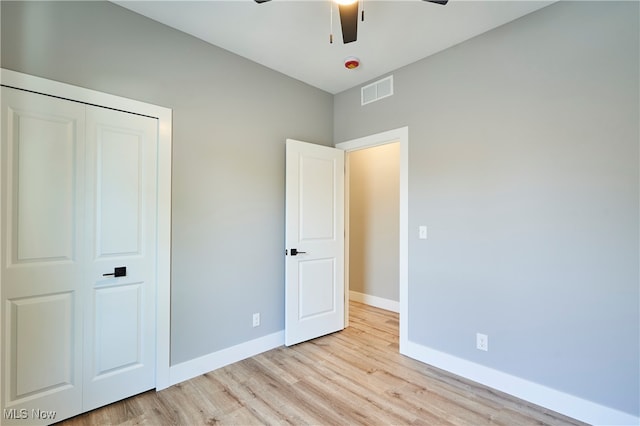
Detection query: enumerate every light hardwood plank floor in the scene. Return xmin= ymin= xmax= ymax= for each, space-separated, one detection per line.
xmin=62 ymin=302 xmax=582 ymax=426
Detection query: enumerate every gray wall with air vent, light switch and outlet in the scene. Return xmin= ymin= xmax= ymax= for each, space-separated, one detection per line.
xmin=334 ymin=2 xmax=640 ymax=416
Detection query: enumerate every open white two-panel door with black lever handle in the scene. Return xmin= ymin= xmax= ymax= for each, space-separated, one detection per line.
xmin=285 ymin=139 xmax=345 ymax=346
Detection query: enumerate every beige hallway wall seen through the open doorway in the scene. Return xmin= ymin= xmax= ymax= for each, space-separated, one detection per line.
xmin=347 ymin=143 xmax=400 ymax=302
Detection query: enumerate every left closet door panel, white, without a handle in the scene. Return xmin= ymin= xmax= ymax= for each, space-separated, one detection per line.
xmin=0 ymin=87 xmax=86 ymax=424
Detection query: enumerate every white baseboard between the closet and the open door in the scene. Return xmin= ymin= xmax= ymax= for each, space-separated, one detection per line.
xmin=169 ymin=331 xmax=284 ymax=385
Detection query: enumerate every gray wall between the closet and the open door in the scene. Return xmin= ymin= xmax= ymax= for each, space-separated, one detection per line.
xmin=1 ymin=1 xmax=333 ymax=364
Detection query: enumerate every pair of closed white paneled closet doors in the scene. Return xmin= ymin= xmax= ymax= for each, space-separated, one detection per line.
xmin=0 ymin=87 xmax=157 ymax=424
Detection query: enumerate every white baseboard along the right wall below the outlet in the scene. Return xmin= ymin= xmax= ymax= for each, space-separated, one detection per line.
xmin=401 ymin=341 xmax=640 ymax=425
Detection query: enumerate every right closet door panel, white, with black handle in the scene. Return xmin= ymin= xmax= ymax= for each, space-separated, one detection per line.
xmin=83 ymin=107 xmax=158 ymax=411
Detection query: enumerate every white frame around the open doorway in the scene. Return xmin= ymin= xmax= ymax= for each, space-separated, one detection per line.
xmin=336 ymin=127 xmax=409 ymax=353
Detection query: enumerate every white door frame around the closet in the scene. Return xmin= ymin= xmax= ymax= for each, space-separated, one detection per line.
xmin=0 ymin=68 xmax=172 ymax=390
